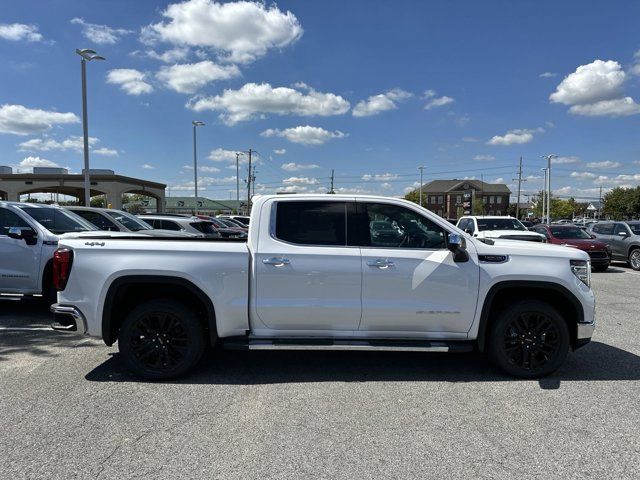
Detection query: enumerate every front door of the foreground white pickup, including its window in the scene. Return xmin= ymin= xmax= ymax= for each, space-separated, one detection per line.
xmin=350 ymin=202 xmax=479 ymax=336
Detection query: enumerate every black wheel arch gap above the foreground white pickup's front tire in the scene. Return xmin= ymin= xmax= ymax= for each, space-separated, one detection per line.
xmin=477 ymin=280 xmax=584 ymax=351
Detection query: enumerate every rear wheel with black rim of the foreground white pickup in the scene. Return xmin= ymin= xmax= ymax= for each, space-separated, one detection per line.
xmin=118 ymin=300 xmax=205 ymax=380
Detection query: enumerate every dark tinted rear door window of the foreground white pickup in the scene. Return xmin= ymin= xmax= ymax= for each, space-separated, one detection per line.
xmin=275 ymin=201 xmax=347 ymax=246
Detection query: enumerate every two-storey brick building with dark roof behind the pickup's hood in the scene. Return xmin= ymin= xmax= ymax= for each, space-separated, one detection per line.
xmin=416 ymin=179 xmax=511 ymax=218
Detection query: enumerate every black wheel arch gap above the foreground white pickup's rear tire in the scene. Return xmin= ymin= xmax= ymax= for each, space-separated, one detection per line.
xmin=102 ymin=275 xmax=218 ymax=346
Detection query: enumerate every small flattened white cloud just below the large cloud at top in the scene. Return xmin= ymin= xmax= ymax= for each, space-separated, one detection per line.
xmin=156 ymin=60 xmax=240 ymax=93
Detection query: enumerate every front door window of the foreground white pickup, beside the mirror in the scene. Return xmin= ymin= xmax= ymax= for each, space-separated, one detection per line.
xmin=358 ymin=203 xmax=446 ymax=249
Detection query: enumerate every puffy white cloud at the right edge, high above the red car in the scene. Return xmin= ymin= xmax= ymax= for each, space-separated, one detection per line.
xmin=549 ymin=60 xmax=640 ymax=117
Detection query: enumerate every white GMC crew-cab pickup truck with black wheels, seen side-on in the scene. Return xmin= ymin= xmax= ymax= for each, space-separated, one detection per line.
xmin=52 ymin=195 xmax=595 ymax=379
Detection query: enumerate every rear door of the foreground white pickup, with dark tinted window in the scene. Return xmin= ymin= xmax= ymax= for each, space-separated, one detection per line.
xmin=253 ymin=200 xmax=362 ymax=335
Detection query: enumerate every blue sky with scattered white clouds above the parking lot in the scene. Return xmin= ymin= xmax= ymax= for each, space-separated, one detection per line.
xmin=0 ymin=0 xmax=640 ymax=200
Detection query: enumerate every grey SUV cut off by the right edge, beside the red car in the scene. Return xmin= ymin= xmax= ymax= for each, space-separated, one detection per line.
xmin=589 ymin=220 xmax=640 ymax=270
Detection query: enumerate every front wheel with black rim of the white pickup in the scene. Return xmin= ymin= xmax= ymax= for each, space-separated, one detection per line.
xmin=488 ymin=300 xmax=569 ymax=378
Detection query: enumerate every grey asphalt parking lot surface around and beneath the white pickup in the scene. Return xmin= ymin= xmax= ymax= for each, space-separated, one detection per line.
xmin=0 ymin=264 xmax=640 ymax=479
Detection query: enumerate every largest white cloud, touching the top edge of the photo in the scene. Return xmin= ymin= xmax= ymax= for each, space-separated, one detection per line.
xmin=141 ymin=0 xmax=303 ymax=63
